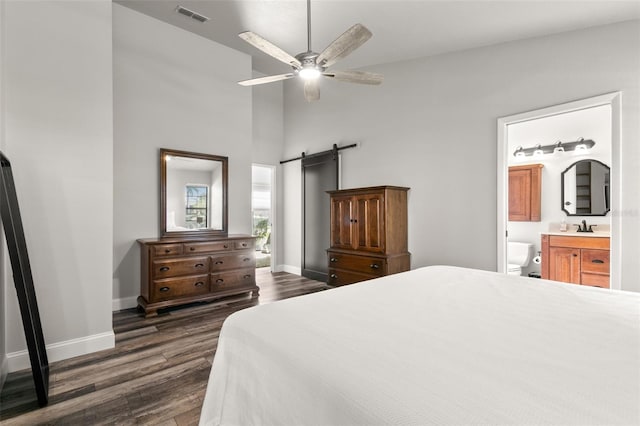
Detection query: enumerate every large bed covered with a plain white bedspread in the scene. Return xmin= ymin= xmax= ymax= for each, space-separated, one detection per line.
xmin=200 ymin=266 xmax=640 ymax=425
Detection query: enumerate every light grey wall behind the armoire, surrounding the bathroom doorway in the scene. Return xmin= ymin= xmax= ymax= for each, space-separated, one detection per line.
xmin=284 ymin=21 xmax=640 ymax=291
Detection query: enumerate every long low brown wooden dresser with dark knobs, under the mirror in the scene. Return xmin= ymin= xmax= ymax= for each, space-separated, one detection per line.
xmin=138 ymin=235 xmax=259 ymax=317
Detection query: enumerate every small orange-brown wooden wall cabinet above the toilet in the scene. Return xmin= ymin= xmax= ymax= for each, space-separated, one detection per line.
xmin=509 ymin=164 xmax=543 ymax=222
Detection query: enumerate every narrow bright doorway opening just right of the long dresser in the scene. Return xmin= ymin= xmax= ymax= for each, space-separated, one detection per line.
xmin=251 ymin=164 xmax=275 ymax=270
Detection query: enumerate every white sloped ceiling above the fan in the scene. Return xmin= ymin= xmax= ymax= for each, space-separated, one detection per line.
xmin=115 ymin=0 xmax=640 ymax=74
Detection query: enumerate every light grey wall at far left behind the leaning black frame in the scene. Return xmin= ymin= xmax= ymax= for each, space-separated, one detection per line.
xmin=2 ymin=0 xmax=114 ymax=370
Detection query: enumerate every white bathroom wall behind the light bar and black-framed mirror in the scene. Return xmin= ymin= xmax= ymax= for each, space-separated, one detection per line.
xmin=507 ymin=105 xmax=612 ymax=275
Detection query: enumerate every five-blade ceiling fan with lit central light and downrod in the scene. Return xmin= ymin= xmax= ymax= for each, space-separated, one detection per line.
xmin=238 ymin=0 xmax=383 ymax=102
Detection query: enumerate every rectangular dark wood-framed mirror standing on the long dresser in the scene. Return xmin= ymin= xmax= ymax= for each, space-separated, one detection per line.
xmin=160 ymin=148 xmax=228 ymax=238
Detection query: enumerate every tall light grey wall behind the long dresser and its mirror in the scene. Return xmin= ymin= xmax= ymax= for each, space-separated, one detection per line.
xmin=113 ymin=4 xmax=253 ymax=309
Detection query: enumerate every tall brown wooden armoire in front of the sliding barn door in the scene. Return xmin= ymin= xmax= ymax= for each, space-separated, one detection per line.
xmin=327 ymin=186 xmax=411 ymax=285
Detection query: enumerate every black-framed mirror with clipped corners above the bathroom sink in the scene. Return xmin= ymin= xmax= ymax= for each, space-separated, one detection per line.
xmin=561 ymin=160 xmax=610 ymax=216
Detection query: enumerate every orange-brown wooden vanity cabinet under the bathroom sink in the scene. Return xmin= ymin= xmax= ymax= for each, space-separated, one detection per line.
xmin=541 ymin=234 xmax=610 ymax=288
